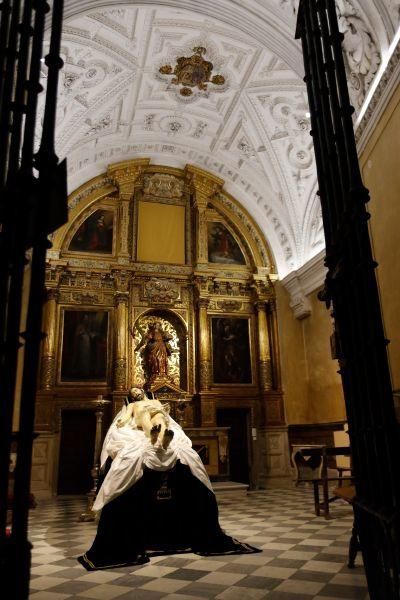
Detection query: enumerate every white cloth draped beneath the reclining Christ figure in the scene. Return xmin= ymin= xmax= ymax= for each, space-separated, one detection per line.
xmin=93 ymin=408 xmax=213 ymax=511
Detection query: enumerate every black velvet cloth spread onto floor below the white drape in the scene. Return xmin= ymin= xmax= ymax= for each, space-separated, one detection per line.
xmin=78 ymin=461 xmax=260 ymax=571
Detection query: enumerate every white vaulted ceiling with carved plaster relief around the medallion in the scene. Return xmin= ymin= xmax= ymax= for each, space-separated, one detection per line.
xmin=39 ymin=0 xmax=400 ymax=277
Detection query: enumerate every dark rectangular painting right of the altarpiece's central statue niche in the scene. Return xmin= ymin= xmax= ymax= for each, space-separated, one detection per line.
xmin=211 ymin=317 xmax=252 ymax=384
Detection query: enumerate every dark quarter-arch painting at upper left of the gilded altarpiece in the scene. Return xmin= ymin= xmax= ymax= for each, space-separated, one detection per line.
xmin=68 ymin=210 xmax=114 ymax=254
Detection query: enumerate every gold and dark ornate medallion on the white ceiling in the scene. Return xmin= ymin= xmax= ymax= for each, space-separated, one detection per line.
xmin=159 ymin=46 xmax=225 ymax=97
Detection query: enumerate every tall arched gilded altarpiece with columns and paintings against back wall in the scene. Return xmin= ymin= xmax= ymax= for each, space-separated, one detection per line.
xmin=36 ymin=159 xmax=289 ymax=491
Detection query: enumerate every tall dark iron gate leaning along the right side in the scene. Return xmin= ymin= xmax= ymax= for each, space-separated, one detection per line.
xmin=296 ymin=0 xmax=400 ymax=600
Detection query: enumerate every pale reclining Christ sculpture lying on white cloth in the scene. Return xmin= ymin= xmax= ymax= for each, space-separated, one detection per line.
xmin=117 ymin=387 xmax=174 ymax=450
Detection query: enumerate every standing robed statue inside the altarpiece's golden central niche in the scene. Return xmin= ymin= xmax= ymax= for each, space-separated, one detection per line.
xmin=135 ymin=321 xmax=172 ymax=383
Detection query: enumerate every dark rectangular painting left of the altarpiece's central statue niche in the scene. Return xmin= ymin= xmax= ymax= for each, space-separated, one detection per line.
xmin=61 ymin=310 xmax=108 ymax=381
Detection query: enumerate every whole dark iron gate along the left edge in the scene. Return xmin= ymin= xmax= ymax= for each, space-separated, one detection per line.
xmin=0 ymin=0 xmax=67 ymax=600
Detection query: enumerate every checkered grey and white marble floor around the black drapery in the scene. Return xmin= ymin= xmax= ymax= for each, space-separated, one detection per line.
xmin=30 ymin=488 xmax=368 ymax=600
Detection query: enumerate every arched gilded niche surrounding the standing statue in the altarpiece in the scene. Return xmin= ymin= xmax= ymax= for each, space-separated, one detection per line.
xmin=132 ymin=309 xmax=187 ymax=390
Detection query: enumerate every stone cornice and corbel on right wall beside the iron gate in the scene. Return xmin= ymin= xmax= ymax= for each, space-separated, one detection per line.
xmin=282 ymin=249 xmax=327 ymax=320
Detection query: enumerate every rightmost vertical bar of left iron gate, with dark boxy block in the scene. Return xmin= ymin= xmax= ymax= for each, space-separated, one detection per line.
xmin=12 ymin=0 xmax=67 ymax=600
